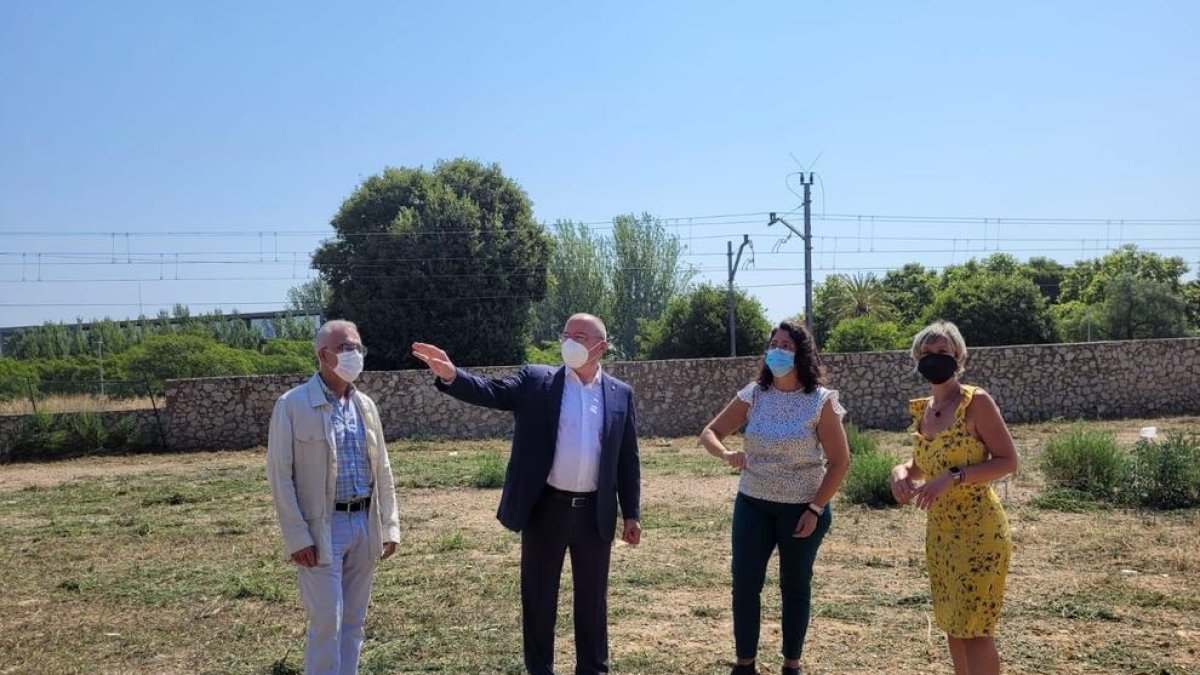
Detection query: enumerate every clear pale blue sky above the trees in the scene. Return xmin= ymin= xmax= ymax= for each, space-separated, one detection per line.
xmin=0 ymin=0 xmax=1200 ymax=325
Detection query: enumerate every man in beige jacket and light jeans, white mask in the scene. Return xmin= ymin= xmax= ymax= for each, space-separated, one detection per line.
xmin=266 ymin=321 xmax=400 ymax=675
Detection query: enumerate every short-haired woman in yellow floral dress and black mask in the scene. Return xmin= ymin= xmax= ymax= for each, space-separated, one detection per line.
xmin=892 ymin=321 xmax=1016 ymax=675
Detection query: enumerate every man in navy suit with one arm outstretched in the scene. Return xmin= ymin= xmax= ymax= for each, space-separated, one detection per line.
xmin=413 ymin=313 xmax=642 ymax=675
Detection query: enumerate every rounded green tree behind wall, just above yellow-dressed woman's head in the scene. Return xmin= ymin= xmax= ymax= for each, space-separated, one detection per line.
xmin=923 ymin=271 xmax=1056 ymax=346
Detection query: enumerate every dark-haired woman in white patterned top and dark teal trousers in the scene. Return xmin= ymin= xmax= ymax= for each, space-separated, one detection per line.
xmin=700 ymin=321 xmax=850 ymax=675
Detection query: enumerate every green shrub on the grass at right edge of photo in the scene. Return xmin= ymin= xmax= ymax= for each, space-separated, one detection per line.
xmin=1128 ymin=434 xmax=1200 ymax=509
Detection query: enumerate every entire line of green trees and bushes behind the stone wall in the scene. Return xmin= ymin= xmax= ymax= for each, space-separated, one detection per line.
xmin=0 ymin=160 xmax=1200 ymax=396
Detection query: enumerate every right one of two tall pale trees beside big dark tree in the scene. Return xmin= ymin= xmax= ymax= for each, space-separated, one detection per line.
xmin=607 ymin=214 xmax=695 ymax=358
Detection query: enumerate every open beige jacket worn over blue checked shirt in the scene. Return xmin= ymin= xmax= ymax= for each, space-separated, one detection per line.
xmin=266 ymin=374 xmax=400 ymax=565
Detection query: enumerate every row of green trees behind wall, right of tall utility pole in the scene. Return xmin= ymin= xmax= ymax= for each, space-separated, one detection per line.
xmin=812 ymin=245 xmax=1200 ymax=352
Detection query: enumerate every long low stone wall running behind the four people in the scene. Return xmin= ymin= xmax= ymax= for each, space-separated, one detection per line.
xmin=159 ymin=339 xmax=1200 ymax=449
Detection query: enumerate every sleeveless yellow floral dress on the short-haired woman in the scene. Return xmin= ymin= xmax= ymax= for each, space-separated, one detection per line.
xmin=908 ymin=384 xmax=1012 ymax=639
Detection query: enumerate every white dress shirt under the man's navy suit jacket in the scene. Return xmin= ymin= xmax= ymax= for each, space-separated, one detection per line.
xmin=546 ymin=368 xmax=604 ymax=492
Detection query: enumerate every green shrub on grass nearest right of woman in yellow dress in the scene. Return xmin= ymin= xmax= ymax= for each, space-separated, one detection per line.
xmin=1039 ymin=426 xmax=1127 ymax=501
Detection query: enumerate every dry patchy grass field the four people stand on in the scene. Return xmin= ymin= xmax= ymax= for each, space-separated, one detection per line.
xmin=0 ymin=417 xmax=1200 ymax=675
